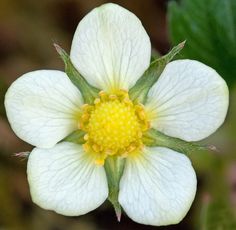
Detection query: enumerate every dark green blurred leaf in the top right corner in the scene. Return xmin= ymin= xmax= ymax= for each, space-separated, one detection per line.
xmin=168 ymin=0 xmax=236 ymax=86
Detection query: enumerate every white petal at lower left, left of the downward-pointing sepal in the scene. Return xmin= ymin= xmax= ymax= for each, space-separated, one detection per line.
xmin=27 ymin=142 xmax=108 ymax=216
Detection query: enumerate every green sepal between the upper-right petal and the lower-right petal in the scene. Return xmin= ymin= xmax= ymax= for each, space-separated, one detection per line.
xmin=143 ymin=129 xmax=216 ymax=154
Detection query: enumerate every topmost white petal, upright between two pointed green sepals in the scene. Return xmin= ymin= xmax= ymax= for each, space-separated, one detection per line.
xmin=70 ymin=3 xmax=151 ymax=91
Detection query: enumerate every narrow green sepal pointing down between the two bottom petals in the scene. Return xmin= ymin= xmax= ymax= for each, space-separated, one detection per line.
xmin=105 ymin=156 xmax=125 ymax=221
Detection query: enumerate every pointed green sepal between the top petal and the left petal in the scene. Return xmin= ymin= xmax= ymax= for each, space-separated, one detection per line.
xmin=54 ymin=43 xmax=100 ymax=104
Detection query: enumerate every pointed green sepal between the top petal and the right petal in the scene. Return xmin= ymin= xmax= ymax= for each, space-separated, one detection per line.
xmin=129 ymin=41 xmax=185 ymax=104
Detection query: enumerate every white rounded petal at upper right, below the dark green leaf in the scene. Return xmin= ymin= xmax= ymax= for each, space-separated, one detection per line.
xmin=146 ymin=60 xmax=229 ymax=141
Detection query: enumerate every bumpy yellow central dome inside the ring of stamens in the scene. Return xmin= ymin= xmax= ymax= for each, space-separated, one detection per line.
xmin=88 ymin=100 xmax=141 ymax=151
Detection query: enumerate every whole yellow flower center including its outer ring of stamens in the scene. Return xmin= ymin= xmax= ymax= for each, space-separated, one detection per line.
xmin=80 ymin=90 xmax=149 ymax=165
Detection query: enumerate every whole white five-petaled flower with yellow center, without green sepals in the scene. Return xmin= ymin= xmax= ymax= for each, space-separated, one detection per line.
xmin=5 ymin=4 xmax=228 ymax=225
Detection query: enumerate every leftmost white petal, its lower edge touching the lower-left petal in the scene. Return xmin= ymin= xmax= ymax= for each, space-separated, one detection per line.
xmin=5 ymin=70 xmax=83 ymax=148
